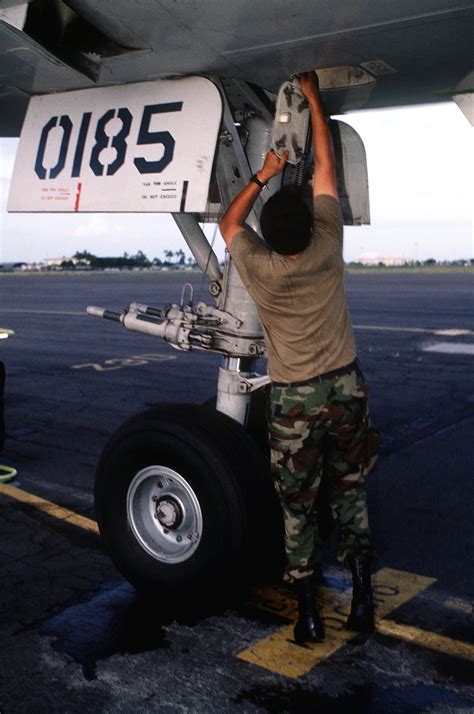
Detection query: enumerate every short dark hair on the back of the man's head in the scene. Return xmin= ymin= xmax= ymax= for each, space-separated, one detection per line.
xmin=260 ymin=186 xmax=313 ymax=255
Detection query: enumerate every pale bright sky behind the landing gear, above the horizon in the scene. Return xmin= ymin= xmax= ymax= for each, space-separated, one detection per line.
xmin=0 ymin=103 xmax=474 ymax=262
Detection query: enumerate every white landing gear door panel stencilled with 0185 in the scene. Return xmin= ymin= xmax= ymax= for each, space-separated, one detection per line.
xmin=8 ymin=77 xmax=222 ymax=213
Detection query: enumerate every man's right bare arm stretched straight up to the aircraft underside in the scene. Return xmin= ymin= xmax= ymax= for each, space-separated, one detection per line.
xmin=299 ymin=72 xmax=337 ymax=198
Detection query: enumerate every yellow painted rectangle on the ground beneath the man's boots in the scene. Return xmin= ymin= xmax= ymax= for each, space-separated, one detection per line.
xmin=237 ymin=568 xmax=436 ymax=679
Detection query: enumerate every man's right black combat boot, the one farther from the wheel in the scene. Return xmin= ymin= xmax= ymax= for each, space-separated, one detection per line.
xmin=346 ymin=553 xmax=375 ymax=632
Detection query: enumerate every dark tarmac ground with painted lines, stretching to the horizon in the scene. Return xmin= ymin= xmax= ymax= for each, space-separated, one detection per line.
xmin=0 ymin=272 xmax=474 ymax=714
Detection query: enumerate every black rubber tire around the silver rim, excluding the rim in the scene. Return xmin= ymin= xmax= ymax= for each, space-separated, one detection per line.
xmin=95 ymin=405 xmax=281 ymax=596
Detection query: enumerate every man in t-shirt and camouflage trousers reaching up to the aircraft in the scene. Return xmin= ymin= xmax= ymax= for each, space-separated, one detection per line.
xmin=220 ymin=72 xmax=376 ymax=644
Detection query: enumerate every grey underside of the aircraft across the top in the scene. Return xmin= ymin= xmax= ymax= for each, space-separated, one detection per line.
xmin=0 ymin=0 xmax=474 ymax=136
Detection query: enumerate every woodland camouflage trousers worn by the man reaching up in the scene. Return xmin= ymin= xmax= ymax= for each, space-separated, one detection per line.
xmin=268 ymin=368 xmax=378 ymax=582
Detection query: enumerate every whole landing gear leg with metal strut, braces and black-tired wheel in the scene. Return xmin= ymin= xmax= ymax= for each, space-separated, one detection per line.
xmin=88 ymin=81 xmax=288 ymax=596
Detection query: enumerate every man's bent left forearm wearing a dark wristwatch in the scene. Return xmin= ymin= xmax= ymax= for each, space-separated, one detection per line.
xmin=220 ymin=151 xmax=288 ymax=250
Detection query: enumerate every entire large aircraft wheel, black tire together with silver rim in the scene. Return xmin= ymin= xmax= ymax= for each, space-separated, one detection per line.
xmin=95 ymin=405 xmax=281 ymax=597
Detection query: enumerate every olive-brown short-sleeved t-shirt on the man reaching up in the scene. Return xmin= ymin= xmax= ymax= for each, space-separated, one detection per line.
xmin=231 ymin=195 xmax=356 ymax=383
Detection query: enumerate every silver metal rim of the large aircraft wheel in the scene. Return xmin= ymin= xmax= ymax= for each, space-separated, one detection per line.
xmin=127 ymin=465 xmax=202 ymax=563
